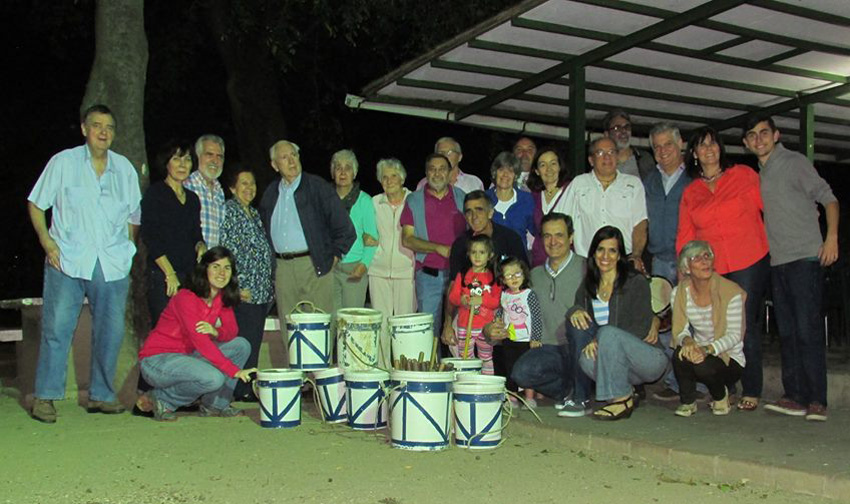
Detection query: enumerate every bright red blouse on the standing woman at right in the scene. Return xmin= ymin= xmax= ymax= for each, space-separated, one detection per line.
xmin=676 ymin=165 xmax=768 ymax=275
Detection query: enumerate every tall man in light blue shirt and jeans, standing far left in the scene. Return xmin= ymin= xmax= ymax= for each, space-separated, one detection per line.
xmin=28 ymin=105 xmax=142 ymax=423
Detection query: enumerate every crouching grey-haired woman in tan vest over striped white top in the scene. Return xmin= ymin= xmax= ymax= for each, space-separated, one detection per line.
xmin=672 ymin=240 xmax=747 ymax=417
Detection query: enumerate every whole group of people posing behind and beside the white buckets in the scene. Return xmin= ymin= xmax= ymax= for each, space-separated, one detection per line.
xmin=29 ymin=105 xmax=838 ymax=422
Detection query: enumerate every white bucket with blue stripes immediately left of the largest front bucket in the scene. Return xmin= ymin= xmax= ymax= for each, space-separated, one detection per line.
xmin=345 ymin=369 xmax=390 ymax=430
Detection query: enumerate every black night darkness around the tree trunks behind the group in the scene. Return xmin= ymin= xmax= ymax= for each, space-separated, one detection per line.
xmin=0 ymin=0 xmax=848 ymax=334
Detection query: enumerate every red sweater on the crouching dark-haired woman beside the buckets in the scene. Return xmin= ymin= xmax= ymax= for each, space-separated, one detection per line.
xmin=139 ymin=289 xmax=239 ymax=378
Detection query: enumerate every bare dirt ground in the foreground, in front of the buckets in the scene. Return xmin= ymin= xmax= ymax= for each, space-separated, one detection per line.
xmin=0 ymin=389 xmax=834 ymax=504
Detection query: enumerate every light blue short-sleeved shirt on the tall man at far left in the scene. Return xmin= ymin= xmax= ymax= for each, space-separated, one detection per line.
xmin=28 ymin=145 xmax=142 ymax=282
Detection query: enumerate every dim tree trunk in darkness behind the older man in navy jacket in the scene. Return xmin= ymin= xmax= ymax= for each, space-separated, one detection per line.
xmin=207 ymin=0 xmax=287 ymax=191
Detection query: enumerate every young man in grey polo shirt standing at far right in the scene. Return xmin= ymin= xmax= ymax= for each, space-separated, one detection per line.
xmin=743 ymin=115 xmax=838 ymax=421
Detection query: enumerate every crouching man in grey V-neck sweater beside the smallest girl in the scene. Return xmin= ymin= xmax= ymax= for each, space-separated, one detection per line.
xmin=484 ymin=212 xmax=584 ymax=409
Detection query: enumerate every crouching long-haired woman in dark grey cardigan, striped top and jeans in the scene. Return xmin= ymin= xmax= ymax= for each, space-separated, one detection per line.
xmin=567 ymin=226 xmax=667 ymax=420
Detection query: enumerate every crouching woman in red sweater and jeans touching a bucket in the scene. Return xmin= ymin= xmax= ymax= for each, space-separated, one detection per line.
xmin=137 ymin=247 xmax=256 ymax=421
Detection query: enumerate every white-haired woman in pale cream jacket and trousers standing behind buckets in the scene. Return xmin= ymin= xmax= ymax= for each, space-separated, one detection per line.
xmin=368 ymin=159 xmax=416 ymax=367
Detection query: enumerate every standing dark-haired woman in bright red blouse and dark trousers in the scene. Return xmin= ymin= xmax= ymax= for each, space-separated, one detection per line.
xmin=676 ymin=127 xmax=770 ymax=411
